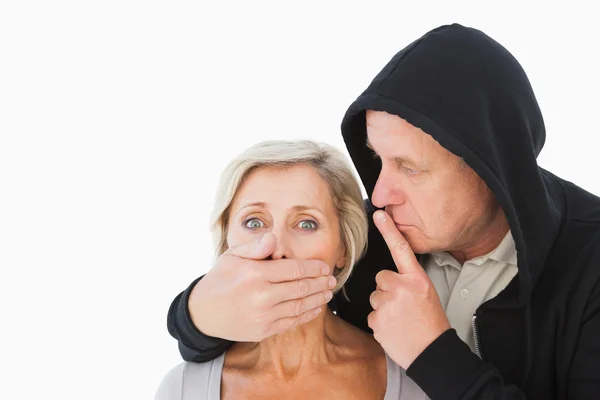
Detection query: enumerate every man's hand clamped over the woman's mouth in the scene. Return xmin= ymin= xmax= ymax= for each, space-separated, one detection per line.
xmin=188 ymin=233 xmax=336 ymax=342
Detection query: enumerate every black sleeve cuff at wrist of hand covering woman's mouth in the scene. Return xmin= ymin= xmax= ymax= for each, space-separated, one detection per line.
xmin=167 ymin=277 xmax=233 ymax=362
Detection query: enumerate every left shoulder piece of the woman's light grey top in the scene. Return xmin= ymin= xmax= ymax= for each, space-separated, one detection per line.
xmin=154 ymin=355 xmax=224 ymax=400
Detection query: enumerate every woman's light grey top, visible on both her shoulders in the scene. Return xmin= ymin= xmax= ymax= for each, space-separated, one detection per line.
xmin=154 ymin=354 xmax=428 ymax=400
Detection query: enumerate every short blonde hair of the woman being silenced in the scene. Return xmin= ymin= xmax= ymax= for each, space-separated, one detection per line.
xmin=210 ymin=140 xmax=368 ymax=293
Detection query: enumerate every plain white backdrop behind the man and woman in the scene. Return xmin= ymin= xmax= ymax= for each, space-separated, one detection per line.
xmin=0 ymin=0 xmax=600 ymax=399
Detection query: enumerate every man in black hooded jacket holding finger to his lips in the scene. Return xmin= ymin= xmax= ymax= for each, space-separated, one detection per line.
xmin=168 ymin=24 xmax=600 ymax=399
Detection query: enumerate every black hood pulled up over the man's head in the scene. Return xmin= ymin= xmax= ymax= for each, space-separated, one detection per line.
xmin=342 ymin=24 xmax=561 ymax=307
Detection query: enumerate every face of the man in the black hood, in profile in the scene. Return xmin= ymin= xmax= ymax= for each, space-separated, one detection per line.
xmin=366 ymin=111 xmax=501 ymax=253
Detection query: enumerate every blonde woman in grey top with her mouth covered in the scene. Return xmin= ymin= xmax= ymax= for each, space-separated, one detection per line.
xmin=156 ymin=141 xmax=426 ymax=400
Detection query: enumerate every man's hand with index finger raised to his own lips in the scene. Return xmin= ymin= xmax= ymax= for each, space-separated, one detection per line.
xmin=369 ymin=211 xmax=450 ymax=369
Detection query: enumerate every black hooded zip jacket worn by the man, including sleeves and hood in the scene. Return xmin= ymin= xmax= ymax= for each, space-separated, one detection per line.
xmin=168 ymin=24 xmax=600 ymax=400
